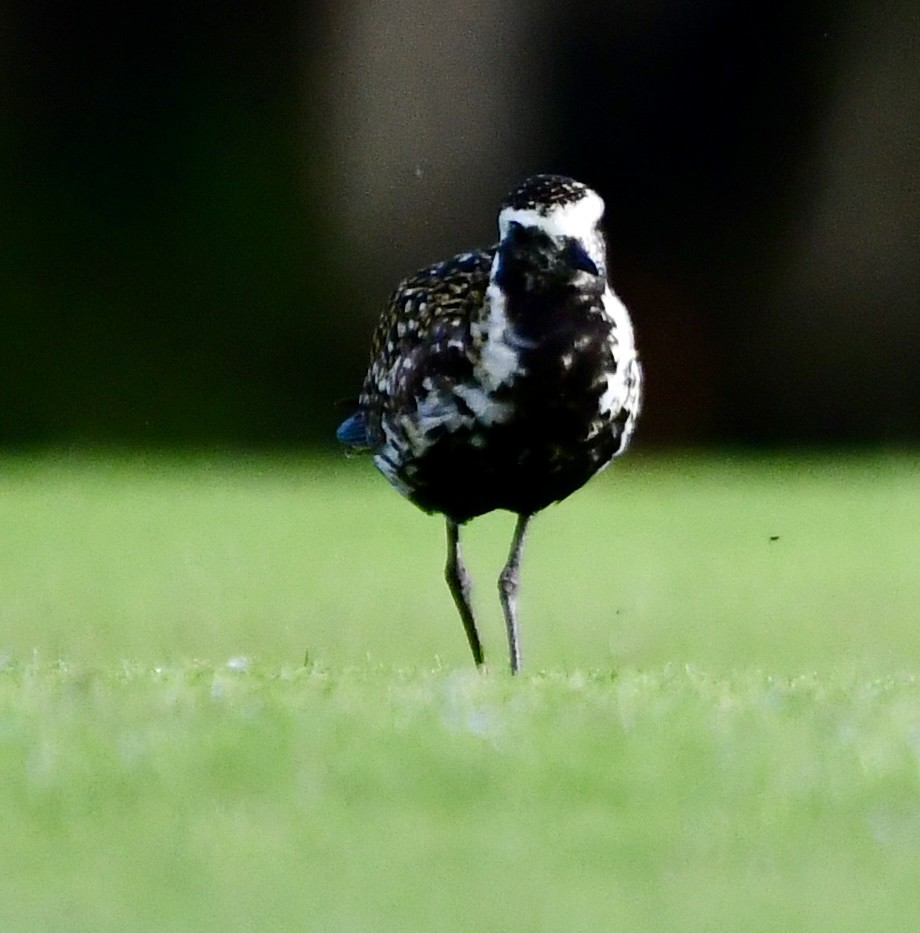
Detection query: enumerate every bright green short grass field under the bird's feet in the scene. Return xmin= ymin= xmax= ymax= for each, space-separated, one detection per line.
xmin=0 ymin=454 xmax=920 ymax=931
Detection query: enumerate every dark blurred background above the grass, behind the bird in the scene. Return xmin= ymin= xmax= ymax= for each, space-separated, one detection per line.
xmin=0 ymin=0 xmax=920 ymax=448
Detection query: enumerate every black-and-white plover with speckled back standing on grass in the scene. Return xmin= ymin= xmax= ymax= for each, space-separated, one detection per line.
xmin=336 ymin=174 xmax=642 ymax=674
